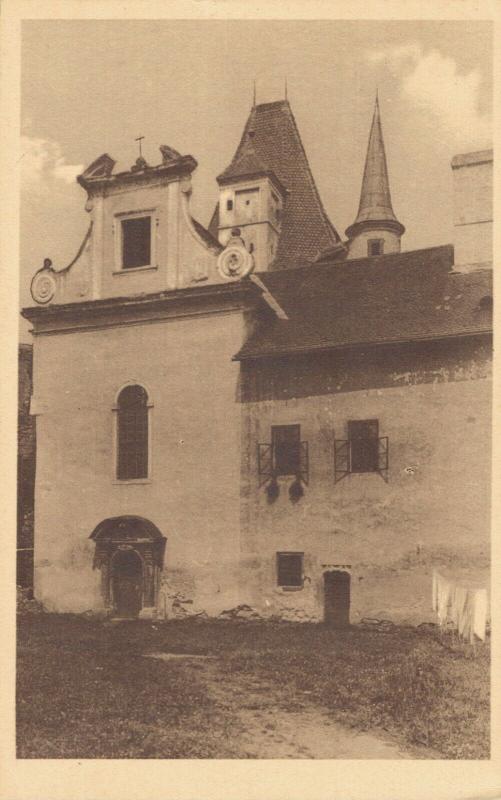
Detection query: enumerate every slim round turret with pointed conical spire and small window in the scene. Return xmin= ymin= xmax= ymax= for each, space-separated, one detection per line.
xmin=346 ymin=95 xmax=405 ymax=258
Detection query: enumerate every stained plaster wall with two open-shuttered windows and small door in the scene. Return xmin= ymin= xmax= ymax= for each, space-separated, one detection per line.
xmin=238 ymin=344 xmax=491 ymax=623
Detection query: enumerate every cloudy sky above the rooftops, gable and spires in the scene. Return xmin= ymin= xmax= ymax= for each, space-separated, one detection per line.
xmin=21 ymin=20 xmax=492 ymax=340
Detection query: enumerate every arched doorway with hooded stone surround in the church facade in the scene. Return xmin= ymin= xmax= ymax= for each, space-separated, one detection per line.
xmin=90 ymin=516 xmax=166 ymax=617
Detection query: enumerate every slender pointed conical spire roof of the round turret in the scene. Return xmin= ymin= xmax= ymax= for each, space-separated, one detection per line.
xmin=346 ymin=90 xmax=405 ymax=238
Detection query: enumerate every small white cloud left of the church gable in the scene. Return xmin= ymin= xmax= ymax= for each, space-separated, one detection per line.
xmin=21 ymin=136 xmax=83 ymax=192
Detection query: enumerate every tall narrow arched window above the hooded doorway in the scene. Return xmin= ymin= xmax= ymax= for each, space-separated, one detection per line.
xmin=117 ymin=386 xmax=148 ymax=481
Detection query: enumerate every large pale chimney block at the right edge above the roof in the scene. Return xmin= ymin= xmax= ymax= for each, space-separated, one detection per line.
xmin=451 ymin=150 xmax=493 ymax=272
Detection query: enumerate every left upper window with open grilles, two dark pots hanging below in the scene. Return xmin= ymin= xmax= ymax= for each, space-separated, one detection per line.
xmin=258 ymin=425 xmax=309 ymax=487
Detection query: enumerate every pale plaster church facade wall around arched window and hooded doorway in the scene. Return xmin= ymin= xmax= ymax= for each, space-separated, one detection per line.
xmin=33 ymin=311 xmax=243 ymax=614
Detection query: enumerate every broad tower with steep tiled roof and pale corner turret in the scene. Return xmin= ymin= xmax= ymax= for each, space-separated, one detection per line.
xmin=209 ymin=100 xmax=344 ymax=271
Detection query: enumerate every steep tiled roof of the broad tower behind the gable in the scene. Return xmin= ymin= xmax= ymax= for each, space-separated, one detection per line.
xmin=209 ymin=100 xmax=340 ymax=270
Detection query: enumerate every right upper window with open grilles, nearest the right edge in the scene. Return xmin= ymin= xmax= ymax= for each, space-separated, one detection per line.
xmin=334 ymin=419 xmax=389 ymax=483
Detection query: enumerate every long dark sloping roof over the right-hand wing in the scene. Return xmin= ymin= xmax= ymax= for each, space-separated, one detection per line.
xmin=236 ymin=245 xmax=492 ymax=359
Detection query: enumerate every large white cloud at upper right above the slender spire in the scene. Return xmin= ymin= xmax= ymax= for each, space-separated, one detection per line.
xmin=367 ymin=43 xmax=492 ymax=148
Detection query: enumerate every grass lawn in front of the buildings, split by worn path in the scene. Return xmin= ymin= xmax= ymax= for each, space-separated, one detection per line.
xmin=17 ymin=614 xmax=489 ymax=759
